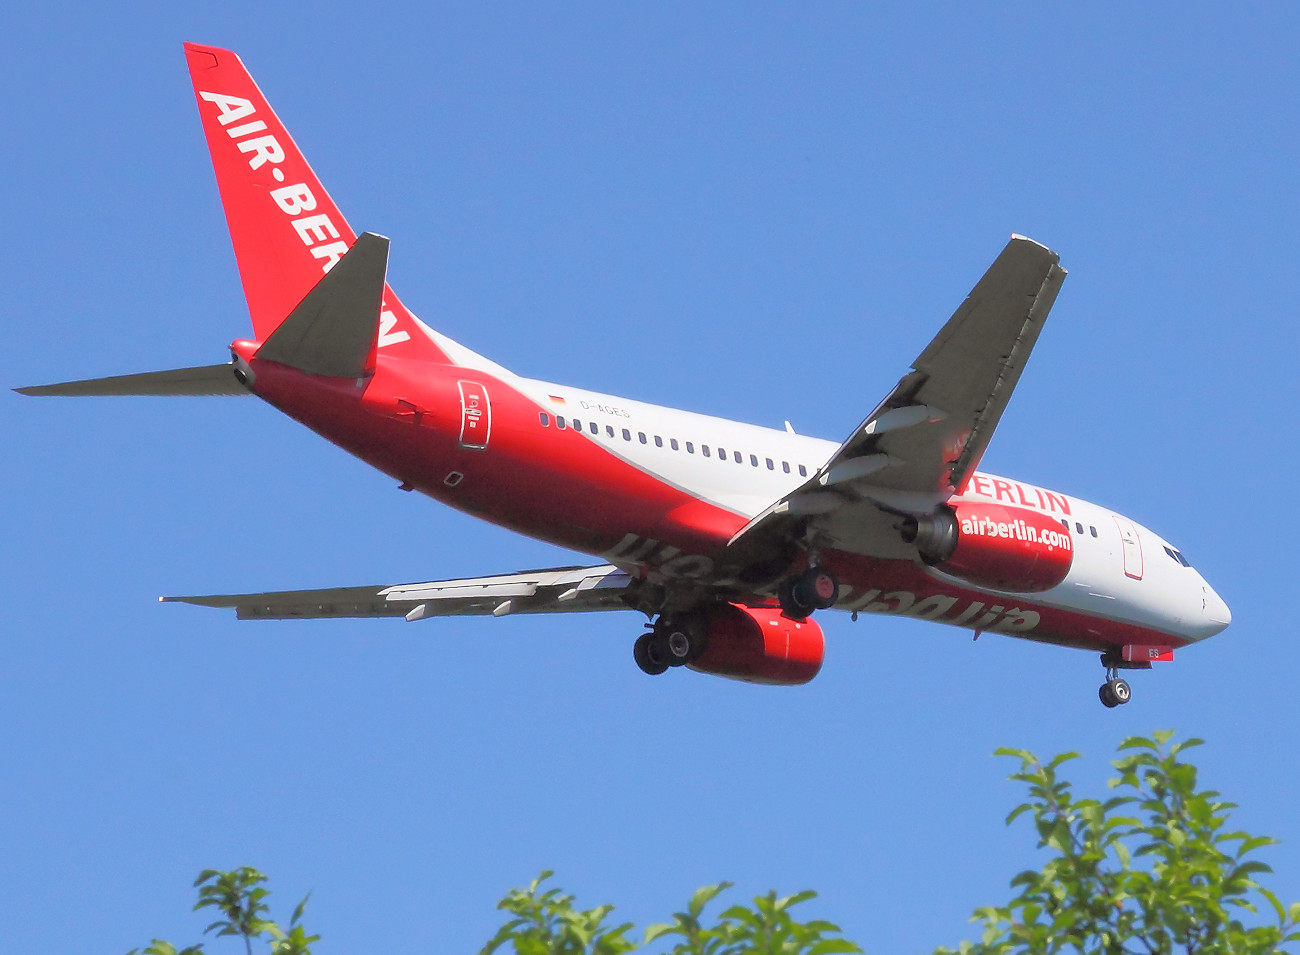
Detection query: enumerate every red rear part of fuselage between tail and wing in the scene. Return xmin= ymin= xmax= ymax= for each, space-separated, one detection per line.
xmin=237 ymin=343 xmax=748 ymax=554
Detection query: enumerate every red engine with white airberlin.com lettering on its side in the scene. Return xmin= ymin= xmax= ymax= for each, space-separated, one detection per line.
xmin=904 ymin=500 xmax=1074 ymax=594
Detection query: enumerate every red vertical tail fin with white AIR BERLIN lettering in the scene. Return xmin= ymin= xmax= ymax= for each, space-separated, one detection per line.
xmin=185 ymin=43 xmax=449 ymax=361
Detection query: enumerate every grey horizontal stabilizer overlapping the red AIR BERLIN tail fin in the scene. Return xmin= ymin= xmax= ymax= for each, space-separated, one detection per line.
xmin=257 ymin=233 xmax=389 ymax=378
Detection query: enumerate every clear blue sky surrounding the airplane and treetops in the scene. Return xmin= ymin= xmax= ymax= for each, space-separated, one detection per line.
xmin=0 ymin=1 xmax=1300 ymax=954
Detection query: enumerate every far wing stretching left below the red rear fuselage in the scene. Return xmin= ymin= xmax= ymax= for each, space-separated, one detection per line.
xmin=159 ymin=564 xmax=632 ymax=620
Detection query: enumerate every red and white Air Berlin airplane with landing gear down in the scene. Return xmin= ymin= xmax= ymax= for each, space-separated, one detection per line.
xmin=17 ymin=43 xmax=1231 ymax=708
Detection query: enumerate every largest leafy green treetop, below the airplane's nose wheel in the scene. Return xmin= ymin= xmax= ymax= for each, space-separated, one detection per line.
xmin=936 ymin=732 xmax=1300 ymax=955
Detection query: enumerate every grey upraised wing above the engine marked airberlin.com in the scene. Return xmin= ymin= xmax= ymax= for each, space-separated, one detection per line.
xmin=731 ymin=235 xmax=1066 ymax=560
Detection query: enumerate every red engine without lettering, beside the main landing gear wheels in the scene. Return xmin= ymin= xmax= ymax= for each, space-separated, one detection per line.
xmin=688 ymin=603 xmax=826 ymax=686
